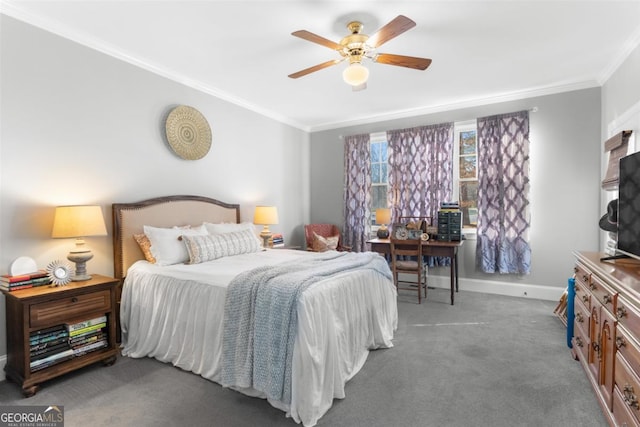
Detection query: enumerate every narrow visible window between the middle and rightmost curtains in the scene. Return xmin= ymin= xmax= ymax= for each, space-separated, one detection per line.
xmin=453 ymin=120 xmax=478 ymax=231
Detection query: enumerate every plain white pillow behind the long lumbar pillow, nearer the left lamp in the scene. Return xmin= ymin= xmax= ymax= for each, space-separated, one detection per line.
xmin=143 ymin=225 xmax=207 ymax=265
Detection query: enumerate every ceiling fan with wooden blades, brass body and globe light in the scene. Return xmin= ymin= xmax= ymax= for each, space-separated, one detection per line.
xmin=289 ymin=15 xmax=431 ymax=90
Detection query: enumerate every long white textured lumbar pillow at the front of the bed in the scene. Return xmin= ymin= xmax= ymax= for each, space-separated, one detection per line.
xmin=182 ymin=230 xmax=260 ymax=264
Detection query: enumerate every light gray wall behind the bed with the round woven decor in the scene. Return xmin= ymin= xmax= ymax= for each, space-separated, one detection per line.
xmin=0 ymin=15 xmax=309 ymax=358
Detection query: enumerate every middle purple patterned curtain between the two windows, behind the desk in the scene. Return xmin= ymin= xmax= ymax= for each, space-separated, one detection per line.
xmin=387 ymin=123 xmax=453 ymax=223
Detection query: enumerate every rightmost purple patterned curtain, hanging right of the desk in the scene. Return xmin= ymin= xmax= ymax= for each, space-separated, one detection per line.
xmin=476 ymin=111 xmax=531 ymax=274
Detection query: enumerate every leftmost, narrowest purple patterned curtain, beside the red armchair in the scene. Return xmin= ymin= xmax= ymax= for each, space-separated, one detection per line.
xmin=342 ymin=134 xmax=371 ymax=252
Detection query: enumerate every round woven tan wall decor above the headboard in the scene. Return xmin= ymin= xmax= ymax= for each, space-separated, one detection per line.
xmin=166 ymin=105 xmax=211 ymax=160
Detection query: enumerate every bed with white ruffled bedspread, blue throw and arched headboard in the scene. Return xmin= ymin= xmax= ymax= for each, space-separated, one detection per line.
xmin=112 ymin=196 xmax=397 ymax=426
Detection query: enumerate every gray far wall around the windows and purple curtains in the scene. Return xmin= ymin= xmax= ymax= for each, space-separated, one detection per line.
xmin=310 ymin=88 xmax=602 ymax=296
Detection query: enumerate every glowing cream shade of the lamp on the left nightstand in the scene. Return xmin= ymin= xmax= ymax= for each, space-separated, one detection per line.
xmin=51 ymin=206 xmax=107 ymax=238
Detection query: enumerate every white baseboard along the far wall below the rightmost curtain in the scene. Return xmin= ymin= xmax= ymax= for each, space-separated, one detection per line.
xmin=428 ymin=275 xmax=565 ymax=301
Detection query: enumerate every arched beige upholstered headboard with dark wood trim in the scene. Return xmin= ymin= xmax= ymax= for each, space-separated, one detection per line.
xmin=111 ymin=196 xmax=240 ymax=279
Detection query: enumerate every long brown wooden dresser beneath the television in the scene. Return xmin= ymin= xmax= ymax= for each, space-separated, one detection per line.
xmin=572 ymin=252 xmax=640 ymax=426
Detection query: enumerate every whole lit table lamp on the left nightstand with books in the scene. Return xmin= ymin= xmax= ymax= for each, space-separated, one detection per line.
xmin=51 ymin=206 xmax=107 ymax=282
